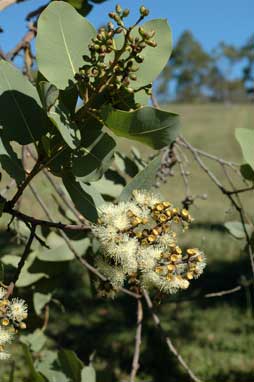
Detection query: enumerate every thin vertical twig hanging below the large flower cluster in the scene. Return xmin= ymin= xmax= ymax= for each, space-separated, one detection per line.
xmin=130 ymin=299 xmax=143 ymax=382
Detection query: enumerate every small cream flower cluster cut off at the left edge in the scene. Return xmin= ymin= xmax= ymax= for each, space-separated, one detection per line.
xmin=0 ymin=287 xmax=28 ymax=360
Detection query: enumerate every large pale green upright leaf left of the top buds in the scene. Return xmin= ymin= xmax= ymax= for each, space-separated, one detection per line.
xmin=36 ymin=1 xmax=96 ymax=89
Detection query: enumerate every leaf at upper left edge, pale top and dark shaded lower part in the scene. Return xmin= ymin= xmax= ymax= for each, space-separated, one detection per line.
xmin=0 ymin=60 xmax=47 ymax=145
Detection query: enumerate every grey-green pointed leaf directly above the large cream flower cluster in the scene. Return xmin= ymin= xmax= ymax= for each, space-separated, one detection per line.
xmin=119 ymin=157 xmax=161 ymax=200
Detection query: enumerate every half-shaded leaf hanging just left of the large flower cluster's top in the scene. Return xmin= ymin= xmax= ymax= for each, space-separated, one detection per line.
xmin=63 ymin=174 xmax=104 ymax=222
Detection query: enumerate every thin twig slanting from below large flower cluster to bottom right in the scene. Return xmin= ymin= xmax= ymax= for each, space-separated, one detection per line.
xmin=143 ymin=290 xmax=201 ymax=382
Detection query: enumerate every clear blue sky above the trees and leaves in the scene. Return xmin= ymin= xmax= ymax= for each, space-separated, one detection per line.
xmin=0 ymin=0 xmax=254 ymax=51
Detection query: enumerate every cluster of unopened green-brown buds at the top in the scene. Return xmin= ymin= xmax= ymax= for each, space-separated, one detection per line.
xmin=76 ymin=5 xmax=157 ymax=107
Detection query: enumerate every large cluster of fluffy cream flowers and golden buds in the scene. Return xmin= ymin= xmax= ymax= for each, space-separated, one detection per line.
xmin=93 ymin=190 xmax=206 ymax=297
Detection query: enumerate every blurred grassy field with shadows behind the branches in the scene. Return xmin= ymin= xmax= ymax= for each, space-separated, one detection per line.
xmin=0 ymin=105 xmax=254 ymax=382
